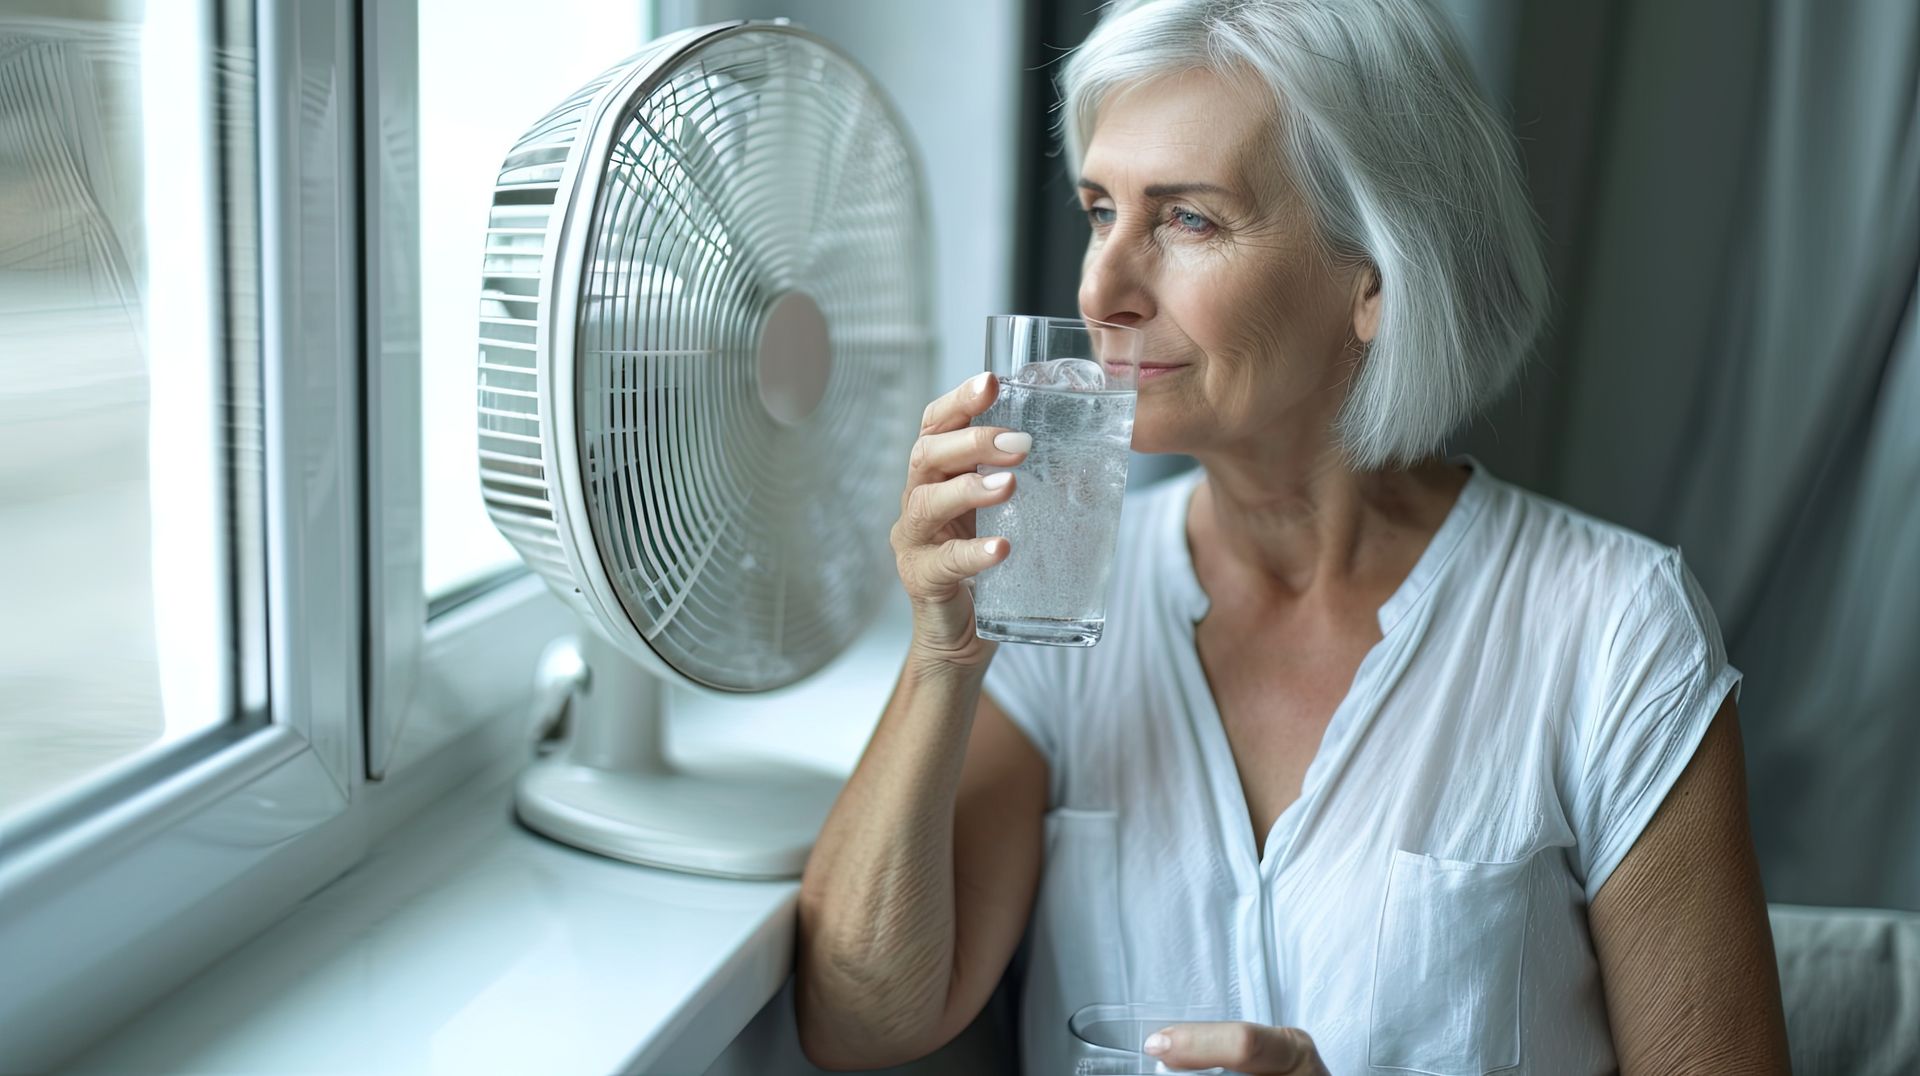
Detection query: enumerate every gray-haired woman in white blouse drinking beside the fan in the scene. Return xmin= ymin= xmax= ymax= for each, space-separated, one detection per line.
xmin=797 ymin=0 xmax=1788 ymax=1076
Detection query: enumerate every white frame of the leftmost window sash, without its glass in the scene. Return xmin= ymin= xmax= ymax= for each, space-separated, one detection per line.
xmin=0 ymin=0 xmax=367 ymax=1070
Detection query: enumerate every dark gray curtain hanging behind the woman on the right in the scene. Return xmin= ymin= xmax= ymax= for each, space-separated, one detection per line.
xmin=1459 ymin=0 xmax=1920 ymax=909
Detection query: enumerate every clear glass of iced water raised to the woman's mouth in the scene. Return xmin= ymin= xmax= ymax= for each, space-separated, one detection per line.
xmin=972 ymin=313 xmax=1142 ymax=646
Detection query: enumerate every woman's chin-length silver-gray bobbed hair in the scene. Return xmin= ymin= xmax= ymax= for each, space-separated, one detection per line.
xmin=1060 ymin=0 xmax=1549 ymax=469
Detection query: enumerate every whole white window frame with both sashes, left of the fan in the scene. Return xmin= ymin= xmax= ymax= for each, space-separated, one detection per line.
xmin=0 ymin=0 xmax=599 ymax=1070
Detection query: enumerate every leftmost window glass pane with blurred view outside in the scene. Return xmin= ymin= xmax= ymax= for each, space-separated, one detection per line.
xmin=0 ymin=0 xmax=238 ymax=820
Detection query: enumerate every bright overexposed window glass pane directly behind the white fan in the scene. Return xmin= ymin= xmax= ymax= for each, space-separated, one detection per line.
xmin=419 ymin=0 xmax=651 ymax=599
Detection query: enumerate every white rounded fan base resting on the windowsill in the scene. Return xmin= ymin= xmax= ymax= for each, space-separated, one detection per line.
xmin=515 ymin=755 xmax=843 ymax=880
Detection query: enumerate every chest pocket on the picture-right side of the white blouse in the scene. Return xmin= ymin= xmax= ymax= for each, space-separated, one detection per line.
xmin=1367 ymin=851 xmax=1532 ymax=1076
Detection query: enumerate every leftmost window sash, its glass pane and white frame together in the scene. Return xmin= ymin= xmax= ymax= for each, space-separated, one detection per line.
xmin=0 ymin=0 xmax=369 ymax=1070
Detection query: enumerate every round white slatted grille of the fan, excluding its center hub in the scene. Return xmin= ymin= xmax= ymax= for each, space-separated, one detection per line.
xmin=480 ymin=25 xmax=933 ymax=692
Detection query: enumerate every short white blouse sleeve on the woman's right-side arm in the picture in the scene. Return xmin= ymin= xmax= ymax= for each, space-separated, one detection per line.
xmin=1572 ymin=550 xmax=1740 ymax=903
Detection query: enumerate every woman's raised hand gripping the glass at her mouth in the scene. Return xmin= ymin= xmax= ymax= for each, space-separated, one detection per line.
xmin=891 ymin=375 xmax=1033 ymax=667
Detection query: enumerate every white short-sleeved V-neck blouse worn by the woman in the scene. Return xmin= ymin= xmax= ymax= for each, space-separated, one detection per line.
xmin=985 ymin=457 xmax=1740 ymax=1076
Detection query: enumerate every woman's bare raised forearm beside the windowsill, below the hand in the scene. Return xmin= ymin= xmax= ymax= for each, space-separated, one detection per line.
xmin=795 ymin=657 xmax=985 ymax=1064
